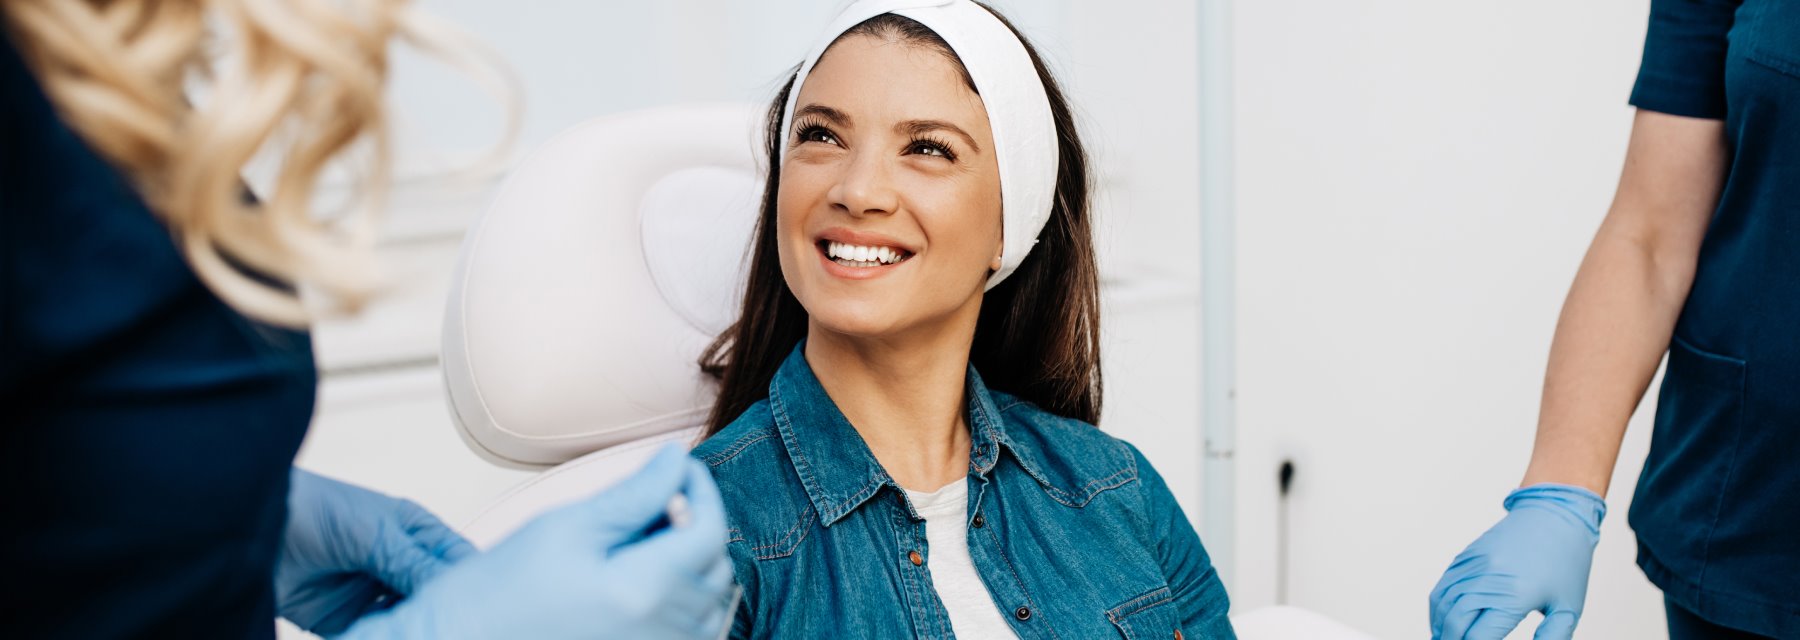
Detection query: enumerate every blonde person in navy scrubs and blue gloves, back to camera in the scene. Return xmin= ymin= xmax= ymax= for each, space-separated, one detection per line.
xmin=0 ymin=0 xmax=731 ymax=638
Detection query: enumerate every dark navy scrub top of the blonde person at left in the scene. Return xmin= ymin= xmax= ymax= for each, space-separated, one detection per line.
xmin=0 ymin=29 xmax=315 ymax=638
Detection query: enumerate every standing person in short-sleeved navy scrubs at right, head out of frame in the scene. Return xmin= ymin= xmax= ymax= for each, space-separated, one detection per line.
xmin=1431 ymin=0 xmax=1800 ymax=640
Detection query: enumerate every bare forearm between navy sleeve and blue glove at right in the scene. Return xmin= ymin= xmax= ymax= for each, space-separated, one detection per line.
xmin=1525 ymin=111 xmax=1726 ymax=496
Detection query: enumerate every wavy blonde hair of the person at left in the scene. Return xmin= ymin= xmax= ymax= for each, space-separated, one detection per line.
xmin=0 ymin=0 xmax=517 ymax=325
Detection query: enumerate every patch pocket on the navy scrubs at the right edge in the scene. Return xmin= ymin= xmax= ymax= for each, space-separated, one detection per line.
xmin=1631 ymin=338 xmax=1744 ymax=579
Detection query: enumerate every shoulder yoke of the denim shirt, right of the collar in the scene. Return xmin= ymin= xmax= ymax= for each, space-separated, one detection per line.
xmin=992 ymin=392 xmax=1154 ymax=507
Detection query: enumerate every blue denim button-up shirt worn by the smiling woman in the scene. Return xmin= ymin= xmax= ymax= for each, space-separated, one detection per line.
xmin=693 ymin=343 xmax=1235 ymax=640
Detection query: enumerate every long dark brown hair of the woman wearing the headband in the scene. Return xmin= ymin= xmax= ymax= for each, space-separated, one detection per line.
xmin=700 ymin=5 xmax=1102 ymax=435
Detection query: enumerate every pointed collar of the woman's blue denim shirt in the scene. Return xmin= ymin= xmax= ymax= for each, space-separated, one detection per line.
xmin=769 ymin=340 xmax=1044 ymax=527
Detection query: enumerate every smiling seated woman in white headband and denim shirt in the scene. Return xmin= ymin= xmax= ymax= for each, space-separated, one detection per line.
xmin=695 ymin=0 xmax=1233 ymax=638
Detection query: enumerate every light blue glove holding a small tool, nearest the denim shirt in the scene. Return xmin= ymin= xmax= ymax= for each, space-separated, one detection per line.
xmin=346 ymin=446 xmax=731 ymax=640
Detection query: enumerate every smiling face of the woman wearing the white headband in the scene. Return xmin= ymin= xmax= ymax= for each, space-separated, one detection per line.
xmin=776 ymin=36 xmax=1001 ymax=345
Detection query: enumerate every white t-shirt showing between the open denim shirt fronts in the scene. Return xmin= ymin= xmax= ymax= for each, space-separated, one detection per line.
xmin=905 ymin=478 xmax=1019 ymax=640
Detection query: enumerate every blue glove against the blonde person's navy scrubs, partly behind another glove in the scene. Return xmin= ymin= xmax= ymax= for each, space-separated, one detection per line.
xmin=275 ymin=469 xmax=475 ymax=635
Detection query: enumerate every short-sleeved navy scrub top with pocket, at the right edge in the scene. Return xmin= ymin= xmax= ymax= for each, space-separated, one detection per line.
xmin=1631 ymin=0 xmax=1800 ymax=638
